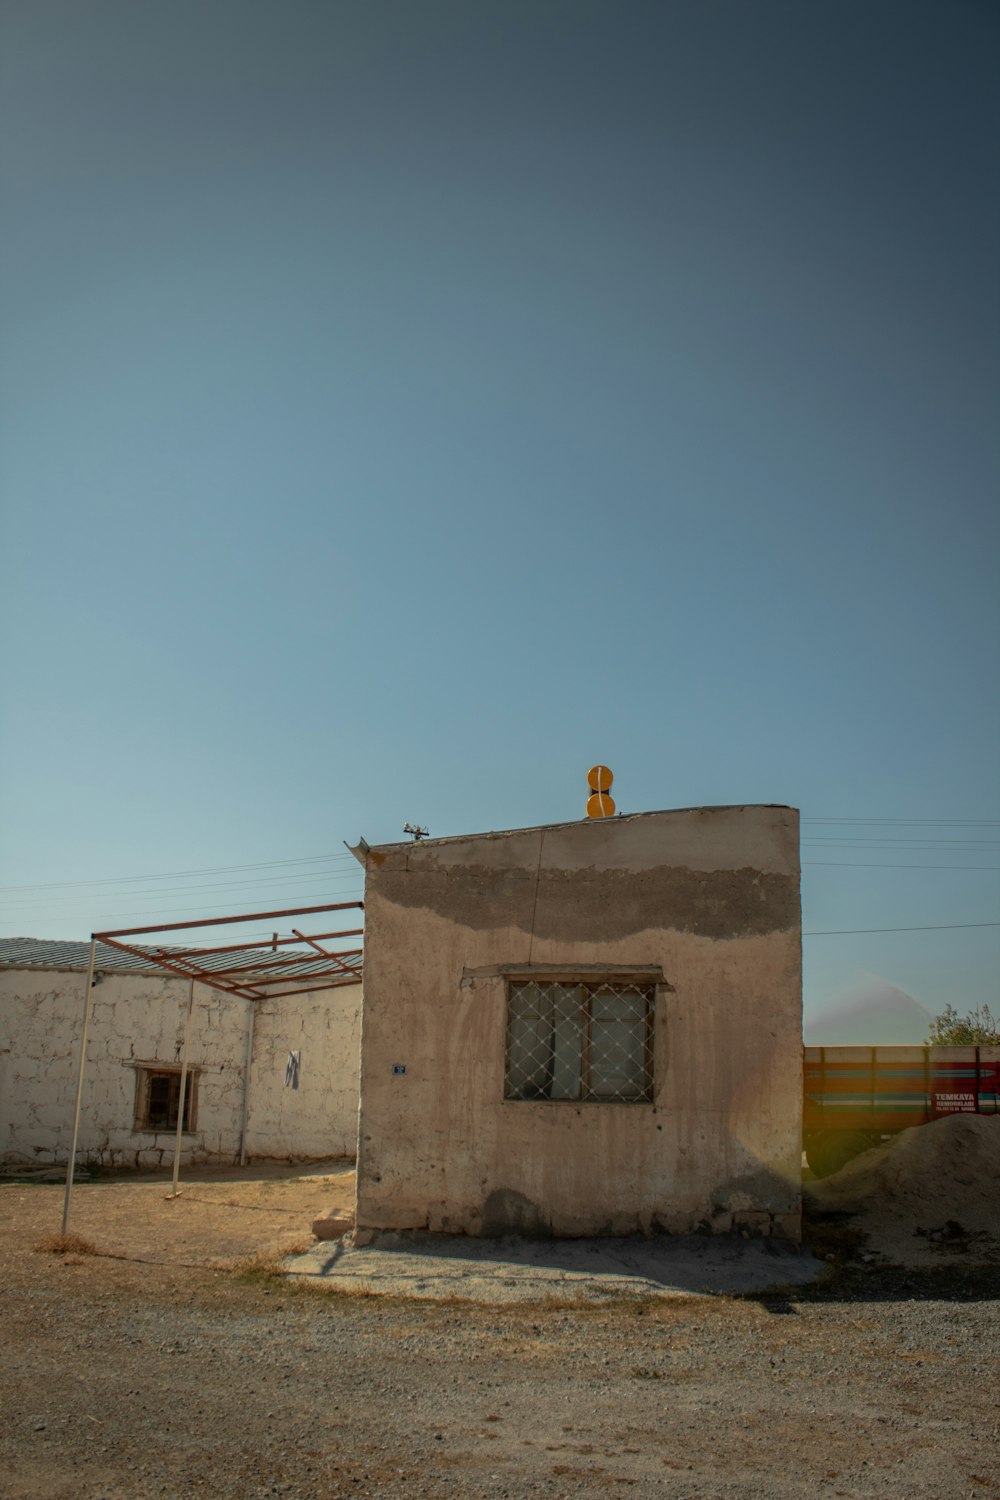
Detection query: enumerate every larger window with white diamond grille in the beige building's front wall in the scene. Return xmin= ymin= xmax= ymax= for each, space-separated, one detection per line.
xmin=507 ymin=980 xmax=654 ymax=1103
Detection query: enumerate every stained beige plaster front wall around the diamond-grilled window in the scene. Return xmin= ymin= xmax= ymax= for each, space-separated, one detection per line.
xmin=357 ymin=807 xmax=802 ymax=1239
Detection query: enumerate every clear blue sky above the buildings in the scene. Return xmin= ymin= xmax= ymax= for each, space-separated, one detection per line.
xmin=0 ymin=0 xmax=1000 ymax=1032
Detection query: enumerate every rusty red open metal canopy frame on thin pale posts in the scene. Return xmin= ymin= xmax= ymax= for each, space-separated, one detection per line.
xmin=63 ymin=902 xmax=364 ymax=1238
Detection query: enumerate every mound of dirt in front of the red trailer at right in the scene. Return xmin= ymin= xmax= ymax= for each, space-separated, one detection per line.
xmin=804 ymin=1115 xmax=1000 ymax=1266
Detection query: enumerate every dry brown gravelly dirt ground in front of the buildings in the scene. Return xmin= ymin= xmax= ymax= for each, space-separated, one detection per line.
xmin=0 ymin=1169 xmax=1000 ymax=1500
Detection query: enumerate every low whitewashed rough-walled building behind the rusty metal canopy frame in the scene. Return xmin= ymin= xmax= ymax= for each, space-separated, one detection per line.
xmin=0 ymin=938 xmax=361 ymax=1167
